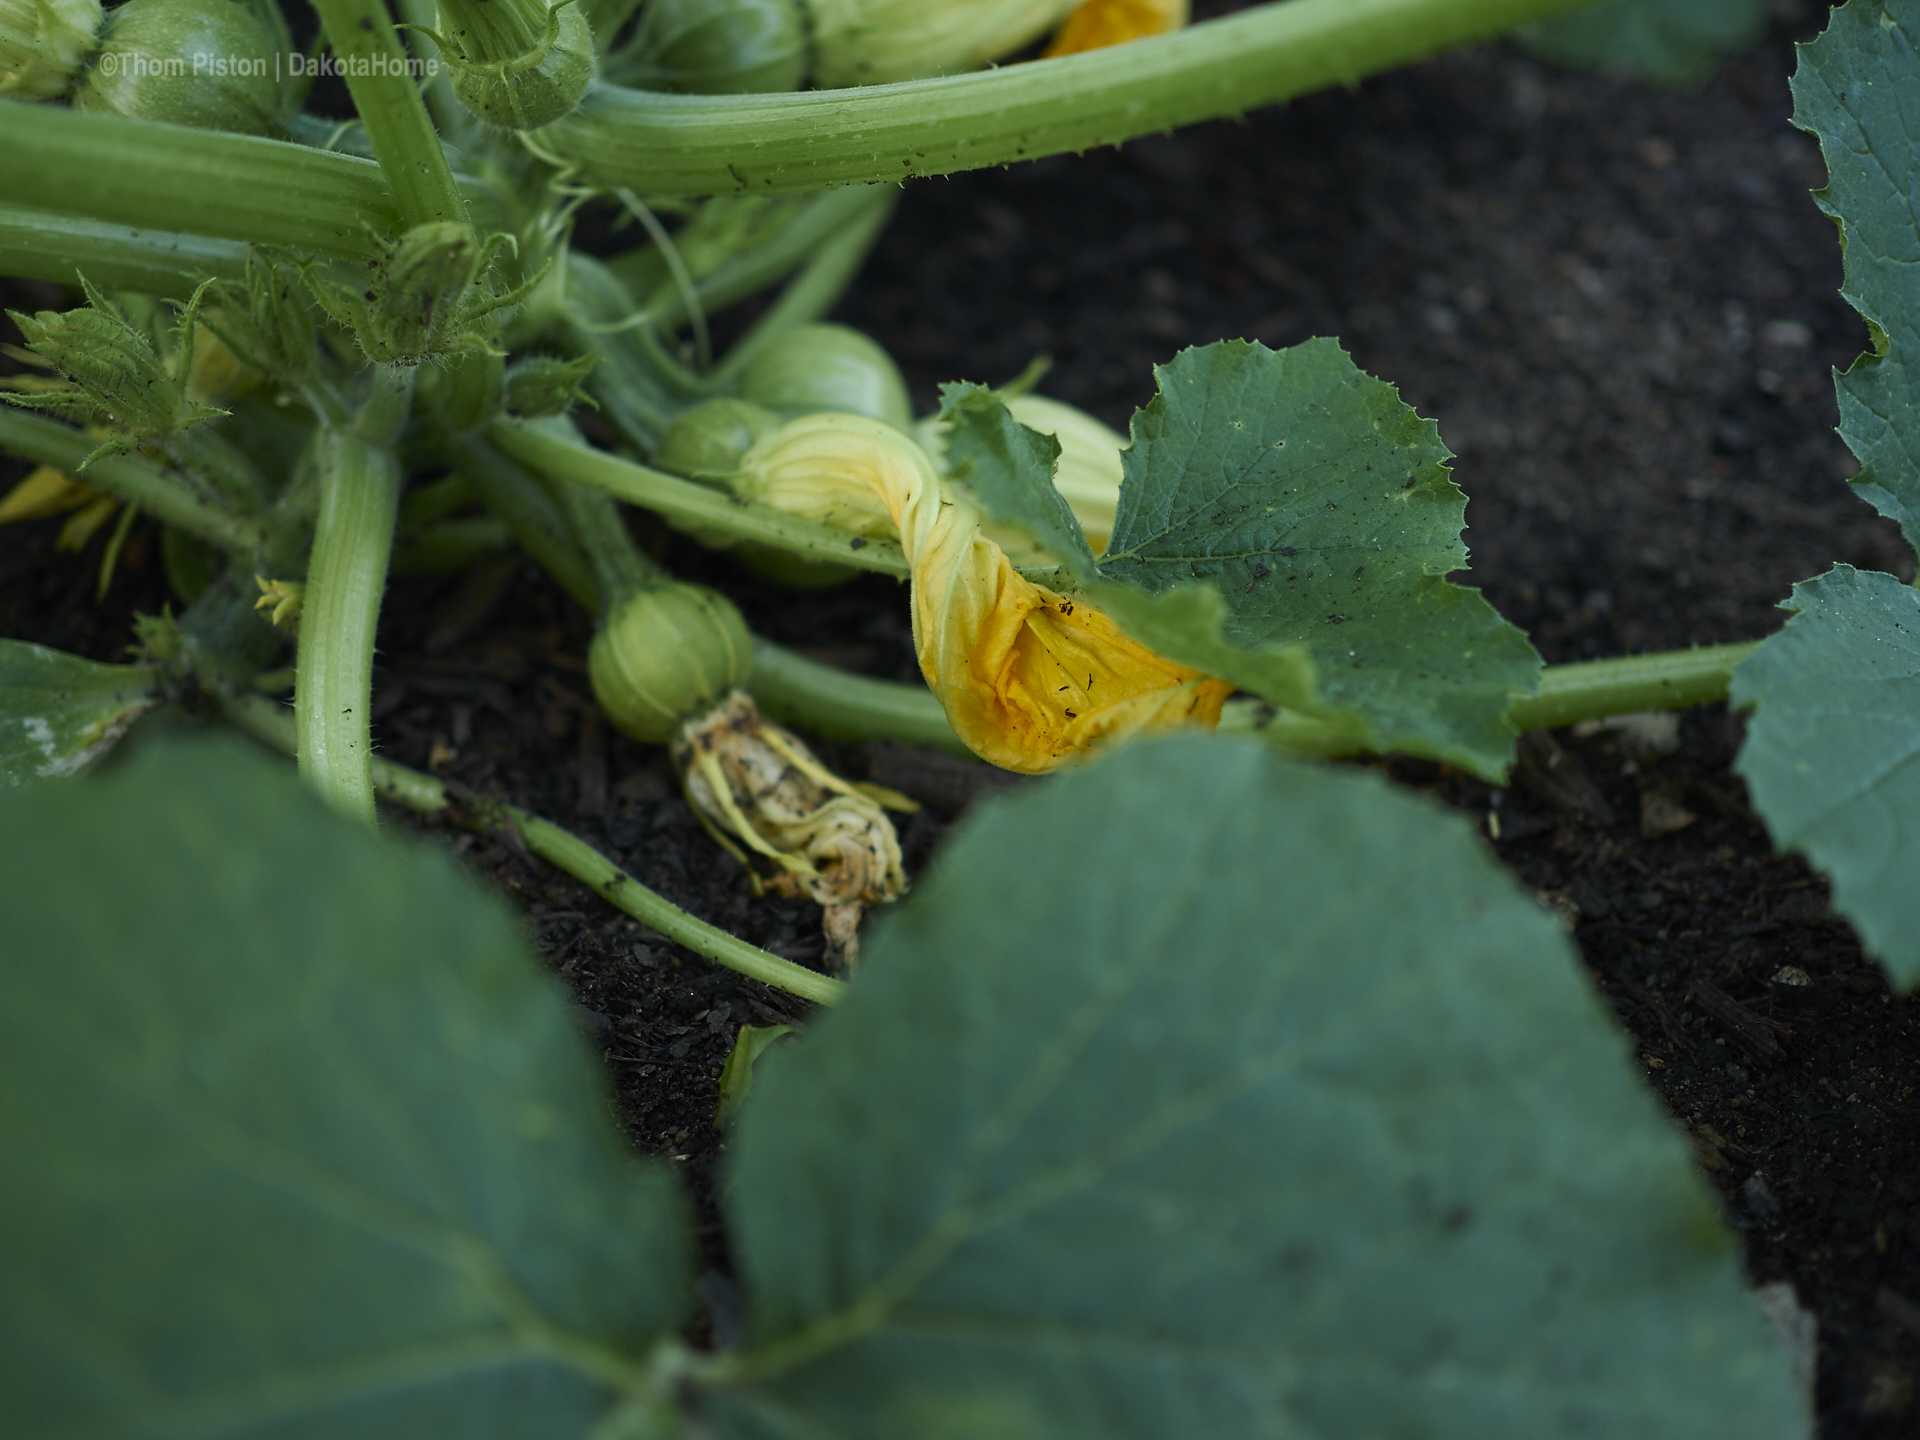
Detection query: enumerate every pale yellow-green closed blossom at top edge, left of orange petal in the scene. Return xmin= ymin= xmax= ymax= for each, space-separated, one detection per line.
xmin=810 ymin=0 xmax=1079 ymax=90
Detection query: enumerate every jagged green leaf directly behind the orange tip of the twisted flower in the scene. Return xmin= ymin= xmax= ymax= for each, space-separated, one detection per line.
xmin=1092 ymin=340 xmax=1540 ymax=776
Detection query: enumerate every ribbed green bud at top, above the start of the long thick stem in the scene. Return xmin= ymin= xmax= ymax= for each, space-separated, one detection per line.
xmin=434 ymin=0 xmax=595 ymax=131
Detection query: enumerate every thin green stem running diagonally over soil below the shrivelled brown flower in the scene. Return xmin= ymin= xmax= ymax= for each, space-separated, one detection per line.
xmin=213 ymin=687 xmax=847 ymax=1004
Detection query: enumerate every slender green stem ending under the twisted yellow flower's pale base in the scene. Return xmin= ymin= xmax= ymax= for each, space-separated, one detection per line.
xmin=488 ymin=420 xmax=910 ymax=580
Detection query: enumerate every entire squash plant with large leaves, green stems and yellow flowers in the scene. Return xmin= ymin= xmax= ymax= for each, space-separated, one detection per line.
xmin=0 ymin=0 xmax=1889 ymax=1440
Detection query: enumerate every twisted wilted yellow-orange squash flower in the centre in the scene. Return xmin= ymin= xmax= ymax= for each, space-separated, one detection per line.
xmin=733 ymin=415 xmax=1233 ymax=774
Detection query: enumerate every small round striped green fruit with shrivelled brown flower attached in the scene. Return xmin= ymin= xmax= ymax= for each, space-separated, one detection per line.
xmin=588 ymin=582 xmax=753 ymax=743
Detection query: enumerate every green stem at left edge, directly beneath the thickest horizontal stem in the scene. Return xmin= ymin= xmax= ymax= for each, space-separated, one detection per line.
xmin=0 ymin=205 xmax=246 ymax=298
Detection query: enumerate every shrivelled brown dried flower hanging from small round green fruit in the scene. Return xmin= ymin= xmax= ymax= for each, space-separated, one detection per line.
xmin=670 ymin=689 xmax=916 ymax=964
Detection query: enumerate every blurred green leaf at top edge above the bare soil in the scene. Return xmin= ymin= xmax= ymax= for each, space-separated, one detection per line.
xmin=1517 ymin=0 xmax=1766 ymax=90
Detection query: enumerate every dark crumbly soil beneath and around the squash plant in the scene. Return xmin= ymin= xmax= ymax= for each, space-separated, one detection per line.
xmin=0 ymin=6 xmax=1920 ymax=1440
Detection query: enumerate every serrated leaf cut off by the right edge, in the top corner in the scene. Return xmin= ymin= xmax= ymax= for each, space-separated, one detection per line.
xmin=1793 ymin=0 xmax=1920 ymax=549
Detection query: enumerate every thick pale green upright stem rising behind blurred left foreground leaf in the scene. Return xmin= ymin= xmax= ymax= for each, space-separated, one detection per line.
xmin=294 ymin=428 xmax=399 ymax=824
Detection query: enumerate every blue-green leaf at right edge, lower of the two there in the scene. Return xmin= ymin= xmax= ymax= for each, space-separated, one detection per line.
xmin=1732 ymin=564 xmax=1920 ymax=989
